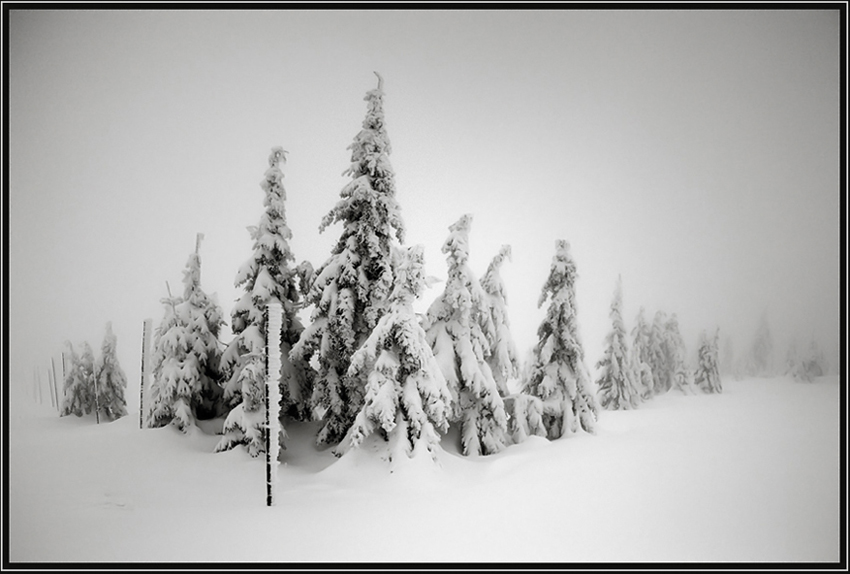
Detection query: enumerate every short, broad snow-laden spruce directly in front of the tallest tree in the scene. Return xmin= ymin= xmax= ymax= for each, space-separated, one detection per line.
xmin=336 ymin=245 xmax=451 ymax=461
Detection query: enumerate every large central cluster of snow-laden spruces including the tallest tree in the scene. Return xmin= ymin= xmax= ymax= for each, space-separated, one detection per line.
xmin=147 ymin=76 xmax=598 ymax=459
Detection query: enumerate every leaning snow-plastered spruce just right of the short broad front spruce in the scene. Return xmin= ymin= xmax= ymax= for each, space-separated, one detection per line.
xmin=423 ymin=214 xmax=508 ymax=455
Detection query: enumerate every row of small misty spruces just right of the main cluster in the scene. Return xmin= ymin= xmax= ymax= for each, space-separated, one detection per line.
xmin=596 ymin=278 xmax=722 ymax=410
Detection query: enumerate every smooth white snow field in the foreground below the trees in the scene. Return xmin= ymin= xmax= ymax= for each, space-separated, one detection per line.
xmin=8 ymin=376 xmax=844 ymax=564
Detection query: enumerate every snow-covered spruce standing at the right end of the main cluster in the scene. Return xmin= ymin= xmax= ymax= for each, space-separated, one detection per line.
xmin=524 ymin=239 xmax=599 ymax=439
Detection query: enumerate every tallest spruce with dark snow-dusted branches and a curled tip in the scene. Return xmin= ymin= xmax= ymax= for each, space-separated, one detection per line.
xmin=291 ymin=76 xmax=404 ymax=450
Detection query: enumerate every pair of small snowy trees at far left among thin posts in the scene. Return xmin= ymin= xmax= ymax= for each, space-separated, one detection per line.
xmin=59 ymin=323 xmax=127 ymax=421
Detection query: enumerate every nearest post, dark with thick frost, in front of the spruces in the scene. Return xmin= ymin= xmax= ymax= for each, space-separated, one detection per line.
xmin=266 ymin=300 xmax=283 ymax=506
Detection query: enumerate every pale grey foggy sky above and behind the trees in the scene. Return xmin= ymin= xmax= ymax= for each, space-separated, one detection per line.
xmin=7 ymin=6 xmax=840 ymax=388
